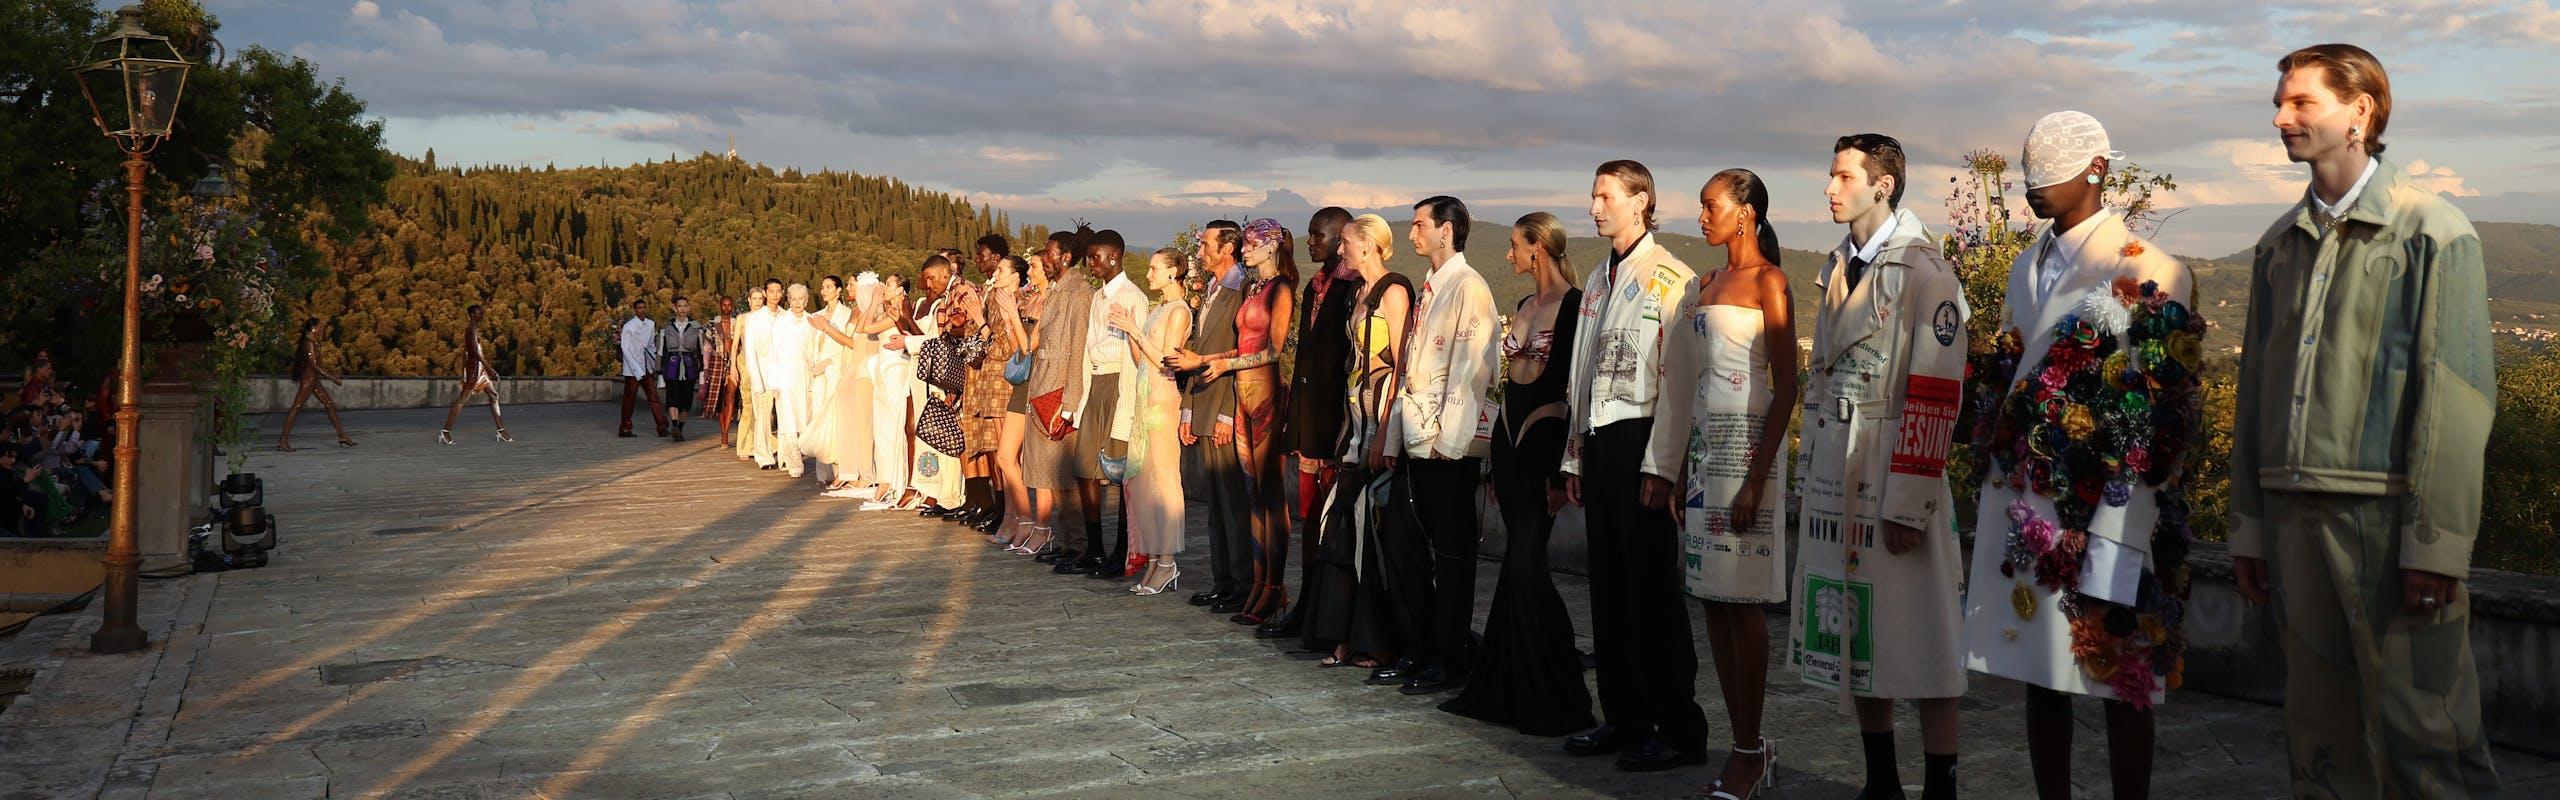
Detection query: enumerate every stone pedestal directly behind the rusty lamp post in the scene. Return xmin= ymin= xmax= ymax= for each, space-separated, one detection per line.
xmin=133 ymin=382 xmax=212 ymax=569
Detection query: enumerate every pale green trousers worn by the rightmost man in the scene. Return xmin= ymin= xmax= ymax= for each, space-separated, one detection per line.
xmin=2263 ymin=492 xmax=2499 ymax=800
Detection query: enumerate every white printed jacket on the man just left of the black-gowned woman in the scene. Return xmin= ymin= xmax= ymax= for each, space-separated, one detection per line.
xmin=1390 ymin=254 xmax=1500 ymax=459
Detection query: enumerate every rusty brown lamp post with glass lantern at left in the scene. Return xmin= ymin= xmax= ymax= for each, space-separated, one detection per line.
xmin=72 ymin=5 xmax=189 ymax=654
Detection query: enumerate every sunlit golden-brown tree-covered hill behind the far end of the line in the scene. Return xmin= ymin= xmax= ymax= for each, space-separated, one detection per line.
xmin=292 ymin=154 xmax=1047 ymax=374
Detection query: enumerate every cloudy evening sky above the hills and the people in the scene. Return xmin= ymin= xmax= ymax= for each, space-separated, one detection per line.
xmin=225 ymin=0 xmax=2560 ymax=256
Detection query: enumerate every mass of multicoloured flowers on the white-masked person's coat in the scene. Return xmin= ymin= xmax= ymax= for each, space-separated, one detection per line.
xmin=1966 ymin=279 xmax=2204 ymax=708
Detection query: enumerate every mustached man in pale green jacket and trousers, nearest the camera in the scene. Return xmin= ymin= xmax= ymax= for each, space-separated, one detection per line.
xmin=2230 ymin=44 xmax=2499 ymax=797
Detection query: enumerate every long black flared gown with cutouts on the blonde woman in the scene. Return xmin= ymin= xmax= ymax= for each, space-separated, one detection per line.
xmin=1441 ymin=290 xmax=1597 ymax=736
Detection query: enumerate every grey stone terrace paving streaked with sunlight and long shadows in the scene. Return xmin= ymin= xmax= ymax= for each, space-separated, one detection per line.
xmin=0 ymin=405 xmax=2560 ymax=800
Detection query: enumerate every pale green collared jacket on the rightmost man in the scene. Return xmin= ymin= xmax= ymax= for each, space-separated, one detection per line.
xmin=2230 ymin=159 xmax=2499 ymax=577
